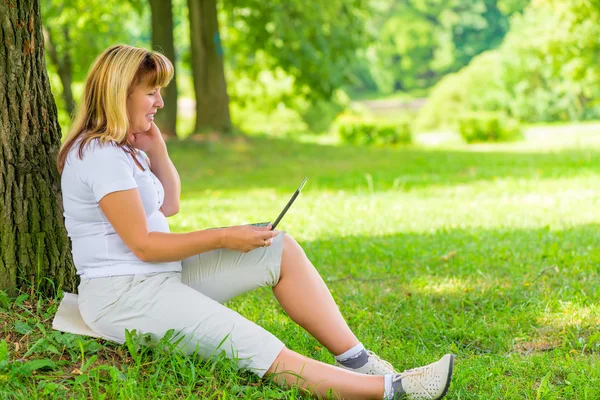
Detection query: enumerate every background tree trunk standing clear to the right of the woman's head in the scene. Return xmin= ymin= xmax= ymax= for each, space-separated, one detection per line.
xmin=188 ymin=0 xmax=231 ymax=133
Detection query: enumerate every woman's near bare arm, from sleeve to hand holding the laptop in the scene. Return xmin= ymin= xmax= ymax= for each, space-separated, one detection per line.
xmin=98 ymin=189 xmax=279 ymax=262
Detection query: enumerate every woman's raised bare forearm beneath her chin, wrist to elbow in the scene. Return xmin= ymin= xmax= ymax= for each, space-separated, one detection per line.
xmin=148 ymin=146 xmax=181 ymax=217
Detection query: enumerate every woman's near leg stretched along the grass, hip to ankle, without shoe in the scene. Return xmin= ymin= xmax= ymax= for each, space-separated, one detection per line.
xmin=80 ymin=273 xmax=394 ymax=399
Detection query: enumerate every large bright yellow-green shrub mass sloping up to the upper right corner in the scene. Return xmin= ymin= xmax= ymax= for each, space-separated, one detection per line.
xmin=418 ymin=0 xmax=600 ymax=129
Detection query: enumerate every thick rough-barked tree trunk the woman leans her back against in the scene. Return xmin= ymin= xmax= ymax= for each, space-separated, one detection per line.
xmin=0 ymin=0 xmax=76 ymax=294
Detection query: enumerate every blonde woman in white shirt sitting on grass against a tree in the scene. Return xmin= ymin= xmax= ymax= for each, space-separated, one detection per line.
xmin=58 ymin=45 xmax=453 ymax=399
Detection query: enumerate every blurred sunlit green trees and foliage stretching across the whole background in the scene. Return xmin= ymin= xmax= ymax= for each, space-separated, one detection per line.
xmin=42 ymin=0 xmax=600 ymax=136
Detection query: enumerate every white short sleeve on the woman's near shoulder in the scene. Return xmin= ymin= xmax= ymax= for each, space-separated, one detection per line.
xmin=79 ymin=143 xmax=137 ymax=202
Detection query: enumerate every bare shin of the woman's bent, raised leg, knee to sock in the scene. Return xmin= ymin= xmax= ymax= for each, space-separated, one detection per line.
xmin=273 ymin=235 xmax=358 ymax=355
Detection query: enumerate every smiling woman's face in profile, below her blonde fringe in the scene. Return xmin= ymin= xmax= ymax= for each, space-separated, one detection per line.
xmin=127 ymin=84 xmax=165 ymax=133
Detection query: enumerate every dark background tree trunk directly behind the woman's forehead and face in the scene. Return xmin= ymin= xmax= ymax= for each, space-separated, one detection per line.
xmin=150 ymin=0 xmax=177 ymax=136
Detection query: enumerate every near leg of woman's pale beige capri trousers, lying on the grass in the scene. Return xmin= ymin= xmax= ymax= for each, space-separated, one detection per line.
xmin=79 ymin=273 xmax=285 ymax=376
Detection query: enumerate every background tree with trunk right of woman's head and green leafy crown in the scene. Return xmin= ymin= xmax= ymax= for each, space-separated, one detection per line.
xmin=182 ymin=0 xmax=366 ymax=131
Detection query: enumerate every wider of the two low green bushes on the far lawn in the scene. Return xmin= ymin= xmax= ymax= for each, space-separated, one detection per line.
xmin=337 ymin=120 xmax=412 ymax=146
